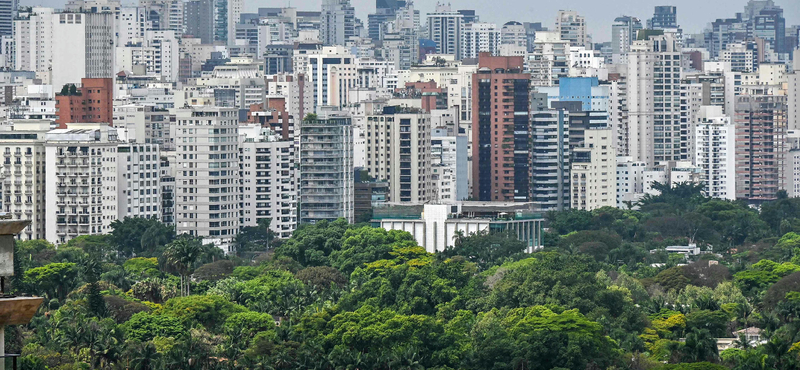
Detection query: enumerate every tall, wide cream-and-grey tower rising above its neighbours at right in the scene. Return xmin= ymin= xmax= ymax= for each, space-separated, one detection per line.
xmin=623 ymin=34 xmax=689 ymax=166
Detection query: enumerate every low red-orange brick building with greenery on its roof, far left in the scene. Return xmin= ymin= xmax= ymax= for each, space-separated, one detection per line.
xmin=56 ymin=78 xmax=114 ymax=128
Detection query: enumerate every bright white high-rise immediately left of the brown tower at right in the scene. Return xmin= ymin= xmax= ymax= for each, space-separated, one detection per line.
xmin=694 ymin=106 xmax=736 ymax=200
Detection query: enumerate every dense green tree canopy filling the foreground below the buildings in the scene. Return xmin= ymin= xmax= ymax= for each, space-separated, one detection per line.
xmin=6 ymin=192 xmax=800 ymax=370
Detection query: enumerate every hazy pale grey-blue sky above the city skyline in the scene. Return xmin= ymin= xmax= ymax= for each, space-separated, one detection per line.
xmin=20 ymin=0 xmax=800 ymax=42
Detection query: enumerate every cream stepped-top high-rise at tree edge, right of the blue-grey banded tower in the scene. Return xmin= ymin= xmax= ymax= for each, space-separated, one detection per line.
xmin=570 ymin=128 xmax=617 ymax=211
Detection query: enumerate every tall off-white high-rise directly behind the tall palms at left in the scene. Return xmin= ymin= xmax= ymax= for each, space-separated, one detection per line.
xmin=170 ymin=106 xmax=240 ymax=252
